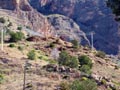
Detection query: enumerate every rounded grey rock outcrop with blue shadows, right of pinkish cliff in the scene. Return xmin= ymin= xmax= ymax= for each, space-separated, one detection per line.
xmin=47 ymin=14 xmax=90 ymax=45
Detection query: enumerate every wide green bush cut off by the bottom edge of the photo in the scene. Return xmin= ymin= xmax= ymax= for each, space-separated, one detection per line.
xmin=70 ymin=79 xmax=97 ymax=90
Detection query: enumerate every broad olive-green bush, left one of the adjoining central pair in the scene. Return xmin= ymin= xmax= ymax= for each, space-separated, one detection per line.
xmin=58 ymin=51 xmax=79 ymax=68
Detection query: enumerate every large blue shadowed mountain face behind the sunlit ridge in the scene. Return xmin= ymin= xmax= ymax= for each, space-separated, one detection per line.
xmin=29 ymin=0 xmax=120 ymax=54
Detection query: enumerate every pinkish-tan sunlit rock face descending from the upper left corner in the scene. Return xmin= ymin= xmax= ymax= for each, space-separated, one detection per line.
xmin=0 ymin=0 xmax=54 ymax=36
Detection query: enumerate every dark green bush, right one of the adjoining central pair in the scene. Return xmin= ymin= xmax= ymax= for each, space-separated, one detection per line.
xmin=78 ymin=55 xmax=92 ymax=68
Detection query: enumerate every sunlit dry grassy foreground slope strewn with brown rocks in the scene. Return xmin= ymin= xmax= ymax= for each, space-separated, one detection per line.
xmin=0 ymin=37 xmax=120 ymax=90
